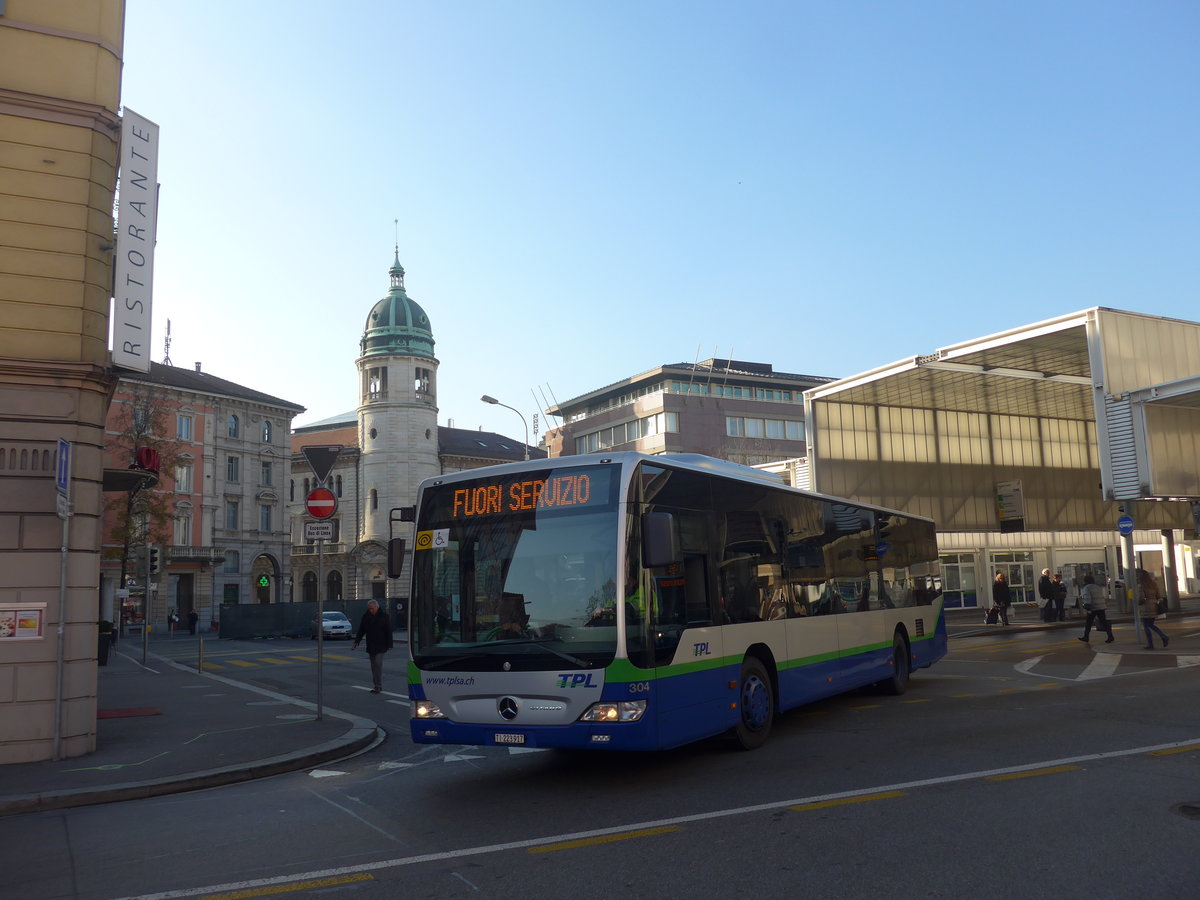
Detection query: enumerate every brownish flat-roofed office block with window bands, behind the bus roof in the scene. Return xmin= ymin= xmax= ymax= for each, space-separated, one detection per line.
xmin=546 ymin=359 xmax=833 ymax=466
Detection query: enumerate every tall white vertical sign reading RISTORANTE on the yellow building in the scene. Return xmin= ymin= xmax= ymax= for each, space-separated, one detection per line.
xmin=113 ymin=107 xmax=158 ymax=372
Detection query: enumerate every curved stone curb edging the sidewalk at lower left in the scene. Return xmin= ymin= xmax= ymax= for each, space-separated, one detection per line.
xmin=0 ymin=654 xmax=388 ymax=817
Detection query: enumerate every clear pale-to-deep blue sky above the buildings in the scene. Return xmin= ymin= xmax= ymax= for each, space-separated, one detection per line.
xmin=122 ymin=0 xmax=1200 ymax=438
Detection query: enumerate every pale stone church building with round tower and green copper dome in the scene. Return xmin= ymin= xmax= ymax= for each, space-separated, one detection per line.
xmin=284 ymin=255 xmax=545 ymax=613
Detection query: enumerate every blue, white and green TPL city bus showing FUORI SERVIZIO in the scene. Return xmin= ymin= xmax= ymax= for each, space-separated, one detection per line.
xmin=408 ymin=452 xmax=947 ymax=750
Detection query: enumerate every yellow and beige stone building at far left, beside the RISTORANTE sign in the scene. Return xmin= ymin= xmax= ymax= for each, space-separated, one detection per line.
xmin=0 ymin=0 xmax=125 ymax=763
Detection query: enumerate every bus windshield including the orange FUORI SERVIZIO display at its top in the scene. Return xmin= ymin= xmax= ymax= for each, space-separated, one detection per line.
xmin=410 ymin=466 xmax=619 ymax=671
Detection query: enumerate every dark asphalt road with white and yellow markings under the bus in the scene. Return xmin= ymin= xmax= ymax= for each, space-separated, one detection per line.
xmin=0 ymin=622 xmax=1200 ymax=899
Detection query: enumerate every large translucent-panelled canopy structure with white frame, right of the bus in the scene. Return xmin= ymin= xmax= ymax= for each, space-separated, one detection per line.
xmin=796 ymin=307 xmax=1200 ymax=608
